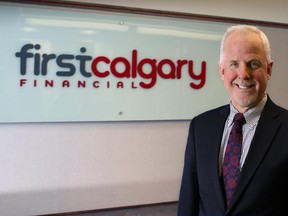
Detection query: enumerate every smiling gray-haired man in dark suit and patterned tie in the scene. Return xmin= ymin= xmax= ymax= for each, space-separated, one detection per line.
xmin=178 ymin=25 xmax=288 ymax=216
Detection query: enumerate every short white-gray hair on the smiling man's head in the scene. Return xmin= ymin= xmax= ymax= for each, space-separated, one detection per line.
xmin=220 ymin=25 xmax=271 ymax=62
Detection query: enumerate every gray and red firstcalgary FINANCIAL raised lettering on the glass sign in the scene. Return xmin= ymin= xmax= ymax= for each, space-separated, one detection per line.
xmin=15 ymin=43 xmax=206 ymax=89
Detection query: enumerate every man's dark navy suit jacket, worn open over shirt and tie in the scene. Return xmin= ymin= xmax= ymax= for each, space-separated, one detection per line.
xmin=178 ymin=98 xmax=288 ymax=216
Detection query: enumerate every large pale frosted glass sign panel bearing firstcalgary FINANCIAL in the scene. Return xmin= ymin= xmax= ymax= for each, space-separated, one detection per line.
xmin=0 ymin=4 xmax=228 ymax=122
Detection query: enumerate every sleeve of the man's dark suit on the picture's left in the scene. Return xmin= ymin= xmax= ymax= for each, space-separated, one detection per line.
xmin=177 ymin=119 xmax=200 ymax=216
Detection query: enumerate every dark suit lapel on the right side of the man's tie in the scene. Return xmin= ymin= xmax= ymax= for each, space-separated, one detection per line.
xmin=227 ymin=99 xmax=280 ymax=213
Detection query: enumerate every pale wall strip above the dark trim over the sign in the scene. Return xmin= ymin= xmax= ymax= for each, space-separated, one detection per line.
xmin=65 ymin=0 xmax=288 ymax=23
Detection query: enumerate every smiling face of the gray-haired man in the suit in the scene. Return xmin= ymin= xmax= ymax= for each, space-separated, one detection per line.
xmin=219 ymin=31 xmax=273 ymax=112
